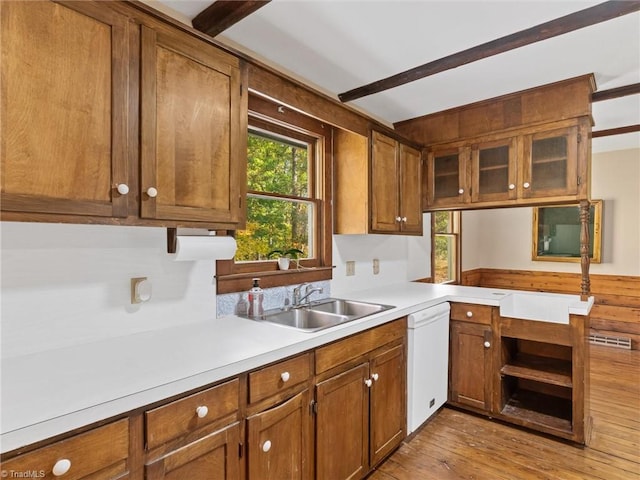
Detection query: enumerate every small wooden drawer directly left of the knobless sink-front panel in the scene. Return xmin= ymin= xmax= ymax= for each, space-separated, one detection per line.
xmin=249 ymin=353 xmax=311 ymax=403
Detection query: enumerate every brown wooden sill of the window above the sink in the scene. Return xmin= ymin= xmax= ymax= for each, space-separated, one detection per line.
xmin=216 ymin=267 xmax=334 ymax=295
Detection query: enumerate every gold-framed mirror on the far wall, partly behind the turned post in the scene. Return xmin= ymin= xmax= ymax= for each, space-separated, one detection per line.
xmin=531 ymin=200 xmax=602 ymax=263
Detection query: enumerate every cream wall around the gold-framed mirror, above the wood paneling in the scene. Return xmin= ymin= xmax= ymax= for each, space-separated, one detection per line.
xmin=462 ymin=149 xmax=640 ymax=275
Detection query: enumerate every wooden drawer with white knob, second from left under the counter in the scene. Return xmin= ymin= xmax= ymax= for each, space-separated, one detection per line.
xmin=145 ymin=378 xmax=240 ymax=449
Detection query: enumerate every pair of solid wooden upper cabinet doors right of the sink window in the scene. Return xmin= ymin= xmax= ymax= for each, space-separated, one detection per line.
xmin=371 ymin=131 xmax=422 ymax=235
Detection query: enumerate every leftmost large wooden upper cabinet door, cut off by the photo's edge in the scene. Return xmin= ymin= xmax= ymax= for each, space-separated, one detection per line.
xmin=0 ymin=2 xmax=129 ymax=217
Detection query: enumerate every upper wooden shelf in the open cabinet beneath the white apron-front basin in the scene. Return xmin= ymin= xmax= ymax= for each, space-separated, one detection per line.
xmin=500 ymin=353 xmax=573 ymax=388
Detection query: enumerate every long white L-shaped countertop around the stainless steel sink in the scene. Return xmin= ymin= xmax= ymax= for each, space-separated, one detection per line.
xmin=0 ymin=282 xmax=592 ymax=452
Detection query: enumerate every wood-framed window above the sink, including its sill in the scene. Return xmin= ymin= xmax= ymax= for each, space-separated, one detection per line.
xmin=216 ymin=95 xmax=332 ymax=293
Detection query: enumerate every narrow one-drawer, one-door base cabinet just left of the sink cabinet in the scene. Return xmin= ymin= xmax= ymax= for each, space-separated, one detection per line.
xmin=245 ymin=353 xmax=313 ymax=480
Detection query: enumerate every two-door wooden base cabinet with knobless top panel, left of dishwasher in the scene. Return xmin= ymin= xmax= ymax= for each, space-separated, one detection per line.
xmin=315 ymin=319 xmax=406 ymax=480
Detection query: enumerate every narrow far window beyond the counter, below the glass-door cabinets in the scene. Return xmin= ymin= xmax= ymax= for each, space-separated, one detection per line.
xmin=431 ymin=212 xmax=461 ymax=283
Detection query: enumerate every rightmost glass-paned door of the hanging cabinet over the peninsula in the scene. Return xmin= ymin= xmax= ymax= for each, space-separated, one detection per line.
xmin=519 ymin=127 xmax=578 ymax=198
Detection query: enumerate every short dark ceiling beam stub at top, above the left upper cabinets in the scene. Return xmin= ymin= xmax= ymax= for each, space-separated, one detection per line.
xmin=192 ymin=0 xmax=271 ymax=37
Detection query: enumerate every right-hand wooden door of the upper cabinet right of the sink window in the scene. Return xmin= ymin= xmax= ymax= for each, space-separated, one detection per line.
xmin=398 ymin=144 xmax=422 ymax=235
